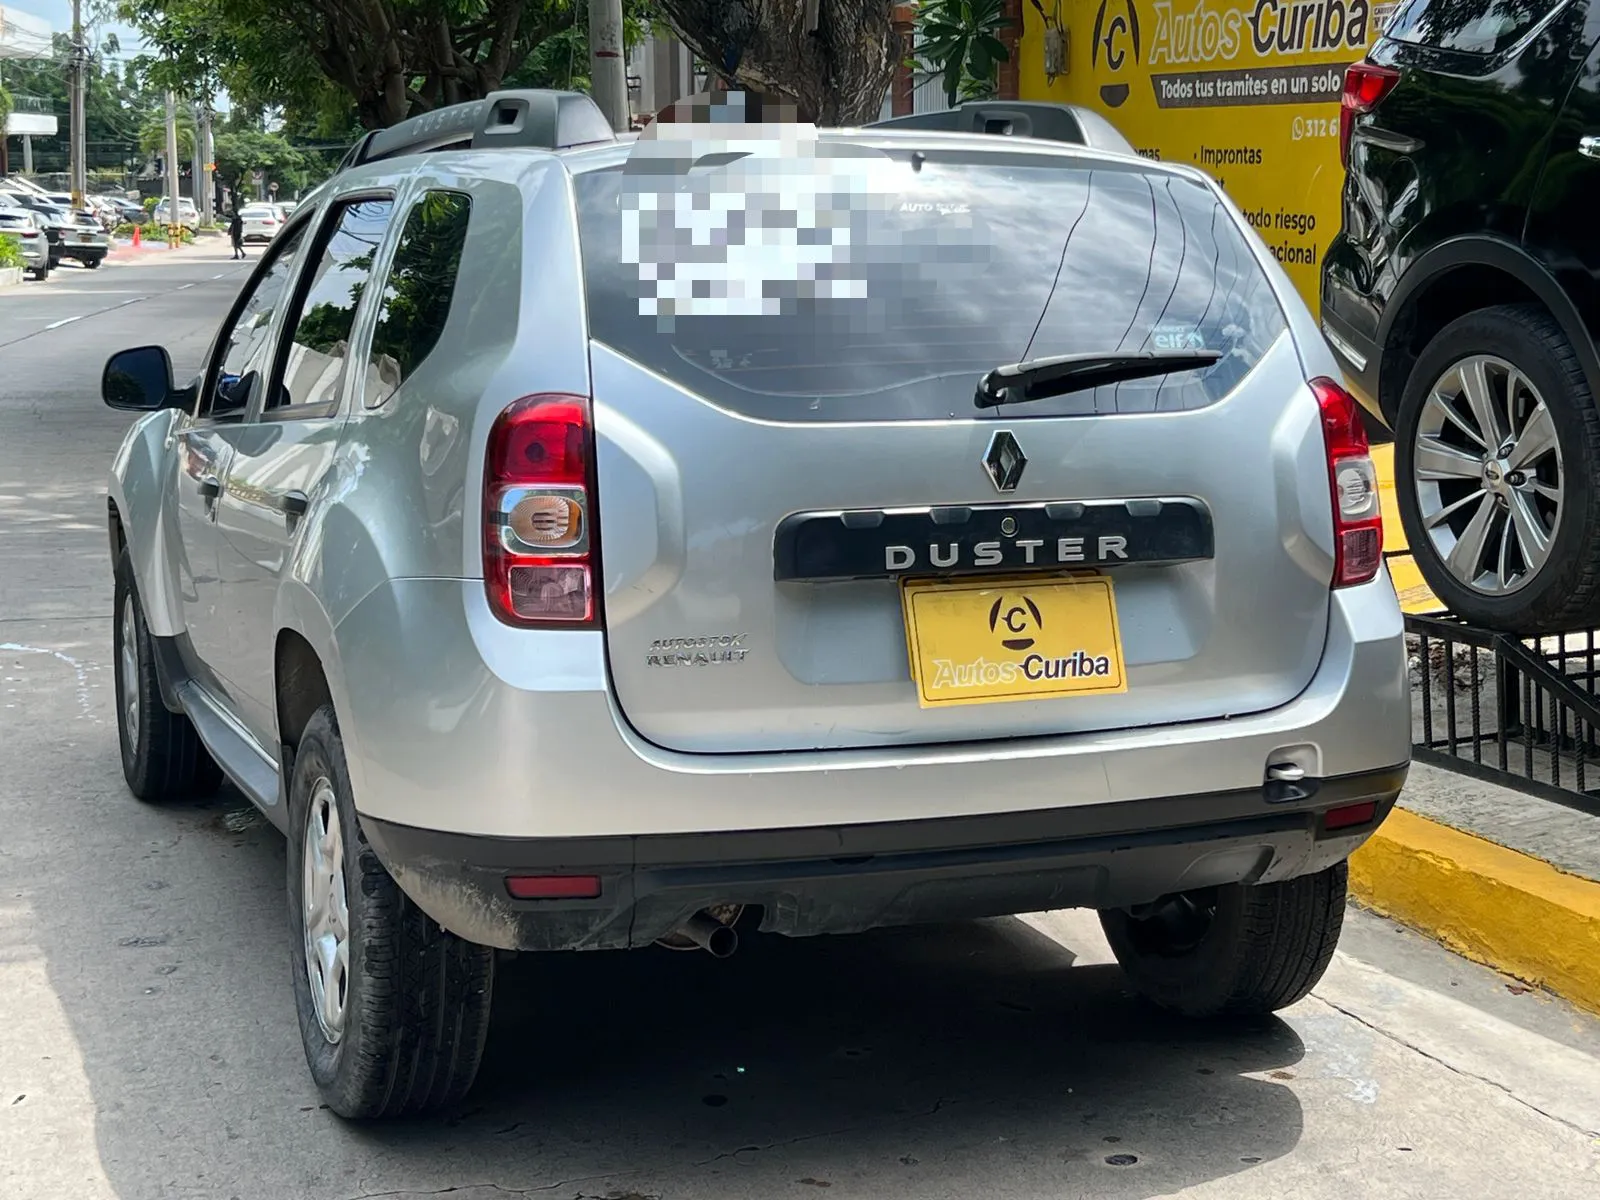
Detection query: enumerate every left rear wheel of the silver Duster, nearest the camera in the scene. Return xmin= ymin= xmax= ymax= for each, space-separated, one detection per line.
xmin=288 ymin=706 xmax=494 ymax=1120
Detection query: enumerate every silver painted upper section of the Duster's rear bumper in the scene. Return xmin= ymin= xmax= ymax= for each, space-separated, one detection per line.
xmin=328 ymin=574 xmax=1411 ymax=838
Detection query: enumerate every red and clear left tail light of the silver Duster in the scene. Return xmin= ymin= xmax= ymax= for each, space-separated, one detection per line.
xmin=483 ymin=395 xmax=600 ymax=629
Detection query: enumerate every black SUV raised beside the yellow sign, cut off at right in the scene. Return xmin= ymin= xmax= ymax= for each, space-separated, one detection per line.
xmin=1322 ymin=0 xmax=1600 ymax=634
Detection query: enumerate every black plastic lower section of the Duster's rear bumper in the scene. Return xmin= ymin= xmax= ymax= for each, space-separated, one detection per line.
xmin=362 ymin=766 xmax=1406 ymax=950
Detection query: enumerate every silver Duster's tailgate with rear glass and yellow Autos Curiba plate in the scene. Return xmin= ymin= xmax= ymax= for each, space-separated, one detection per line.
xmin=576 ymin=139 xmax=1331 ymax=752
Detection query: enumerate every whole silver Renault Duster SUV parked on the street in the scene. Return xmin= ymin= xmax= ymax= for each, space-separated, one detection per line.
xmin=104 ymin=93 xmax=1410 ymax=1117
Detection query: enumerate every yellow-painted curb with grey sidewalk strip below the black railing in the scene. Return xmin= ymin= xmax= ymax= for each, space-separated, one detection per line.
xmin=1350 ymin=763 xmax=1600 ymax=1011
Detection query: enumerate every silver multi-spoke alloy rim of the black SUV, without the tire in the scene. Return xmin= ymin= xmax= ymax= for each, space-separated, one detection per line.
xmin=1411 ymin=354 xmax=1563 ymax=595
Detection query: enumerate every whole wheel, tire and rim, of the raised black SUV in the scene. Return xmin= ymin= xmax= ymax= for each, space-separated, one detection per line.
xmin=1395 ymin=304 xmax=1600 ymax=635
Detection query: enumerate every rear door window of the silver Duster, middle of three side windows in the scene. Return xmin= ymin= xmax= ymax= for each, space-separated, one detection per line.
xmin=264 ymin=200 xmax=394 ymax=414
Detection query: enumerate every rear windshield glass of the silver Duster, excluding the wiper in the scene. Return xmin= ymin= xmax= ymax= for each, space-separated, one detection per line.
xmin=574 ymin=146 xmax=1285 ymax=421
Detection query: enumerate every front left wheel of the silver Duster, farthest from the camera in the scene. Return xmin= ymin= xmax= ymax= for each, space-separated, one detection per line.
xmin=112 ymin=549 xmax=222 ymax=803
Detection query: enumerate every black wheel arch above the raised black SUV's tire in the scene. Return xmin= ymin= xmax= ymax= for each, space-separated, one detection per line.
xmin=1378 ymin=235 xmax=1600 ymax=429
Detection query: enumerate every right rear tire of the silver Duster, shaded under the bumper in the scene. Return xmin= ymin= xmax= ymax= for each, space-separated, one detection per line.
xmin=1101 ymin=862 xmax=1349 ymax=1018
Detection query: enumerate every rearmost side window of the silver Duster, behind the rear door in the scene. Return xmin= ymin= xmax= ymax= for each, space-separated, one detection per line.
xmin=365 ymin=192 xmax=472 ymax=408
